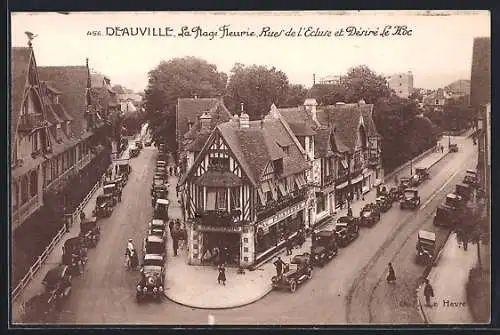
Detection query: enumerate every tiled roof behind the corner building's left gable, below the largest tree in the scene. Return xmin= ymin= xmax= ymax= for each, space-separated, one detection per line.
xmin=176 ymin=98 xmax=219 ymax=143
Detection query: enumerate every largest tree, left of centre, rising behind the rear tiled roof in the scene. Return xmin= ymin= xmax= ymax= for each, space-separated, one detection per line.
xmin=144 ymin=57 xmax=227 ymax=149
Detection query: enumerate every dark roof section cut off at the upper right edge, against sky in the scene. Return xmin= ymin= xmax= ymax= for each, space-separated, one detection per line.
xmin=470 ymin=37 xmax=491 ymax=107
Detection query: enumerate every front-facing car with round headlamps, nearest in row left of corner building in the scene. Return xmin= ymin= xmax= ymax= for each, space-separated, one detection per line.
xmin=136 ymin=254 xmax=165 ymax=301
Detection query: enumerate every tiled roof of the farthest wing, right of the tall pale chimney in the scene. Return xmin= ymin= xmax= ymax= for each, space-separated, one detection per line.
xmin=317 ymin=103 xmax=374 ymax=150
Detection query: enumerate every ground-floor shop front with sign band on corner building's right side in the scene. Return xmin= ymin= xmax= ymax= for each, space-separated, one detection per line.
xmin=255 ymin=200 xmax=306 ymax=263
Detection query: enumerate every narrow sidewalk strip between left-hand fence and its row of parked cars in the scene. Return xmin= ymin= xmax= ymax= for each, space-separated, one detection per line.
xmin=12 ymin=146 xmax=132 ymax=323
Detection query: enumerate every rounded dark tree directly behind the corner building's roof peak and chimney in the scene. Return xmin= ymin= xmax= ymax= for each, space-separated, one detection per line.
xmin=224 ymin=63 xmax=289 ymax=120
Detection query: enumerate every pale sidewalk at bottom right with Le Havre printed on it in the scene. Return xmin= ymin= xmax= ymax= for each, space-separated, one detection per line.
xmin=417 ymin=234 xmax=477 ymax=324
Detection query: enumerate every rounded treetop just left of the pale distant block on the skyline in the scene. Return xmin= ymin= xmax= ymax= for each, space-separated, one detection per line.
xmin=343 ymin=65 xmax=391 ymax=103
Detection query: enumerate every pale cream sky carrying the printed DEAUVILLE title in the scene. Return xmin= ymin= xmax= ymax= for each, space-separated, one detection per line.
xmin=11 ymin=11 xmax=490 ymax=91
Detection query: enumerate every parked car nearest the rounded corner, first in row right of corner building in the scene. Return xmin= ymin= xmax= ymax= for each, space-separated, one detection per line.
xmin=271 ymin=253 xmax=312 ymax=293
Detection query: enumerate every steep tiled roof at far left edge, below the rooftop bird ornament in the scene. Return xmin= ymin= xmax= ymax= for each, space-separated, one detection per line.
xmin=10 ymin=47 xmax=31 ymax=159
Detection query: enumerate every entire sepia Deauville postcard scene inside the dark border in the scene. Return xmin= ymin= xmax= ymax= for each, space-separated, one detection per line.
xmin=9 ymin=11 xmax=491 ymax=327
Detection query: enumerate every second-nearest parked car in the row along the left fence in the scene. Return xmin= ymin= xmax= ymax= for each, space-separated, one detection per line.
xmin=42 ymin=264 xmax=71 ymax=307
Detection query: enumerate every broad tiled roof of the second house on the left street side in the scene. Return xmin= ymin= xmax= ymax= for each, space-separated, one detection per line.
xmin=38 ymin=66 xmax=88 ymax=137
